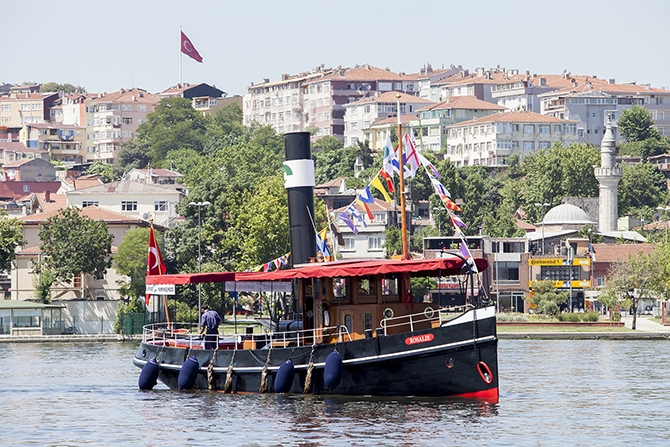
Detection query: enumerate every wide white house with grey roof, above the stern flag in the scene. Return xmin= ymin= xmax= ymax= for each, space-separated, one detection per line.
xmin=65 ymin=180 xmax=185 ymax=228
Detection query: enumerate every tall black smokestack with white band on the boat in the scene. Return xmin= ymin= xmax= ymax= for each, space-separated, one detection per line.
xmin=284 ymin=132 xmax=316 ymax=265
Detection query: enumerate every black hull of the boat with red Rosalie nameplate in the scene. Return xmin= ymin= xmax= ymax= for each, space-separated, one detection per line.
xmin=133 ymin=308 xmax=498 ymax=402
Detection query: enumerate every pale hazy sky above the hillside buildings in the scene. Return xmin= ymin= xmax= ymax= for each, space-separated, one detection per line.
xmin=0 ymin=0 xmax=670 ymax=95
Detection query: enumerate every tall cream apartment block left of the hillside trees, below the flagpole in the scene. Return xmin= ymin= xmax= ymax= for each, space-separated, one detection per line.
xmin=86 ymin=88 xmax=160 ymax=164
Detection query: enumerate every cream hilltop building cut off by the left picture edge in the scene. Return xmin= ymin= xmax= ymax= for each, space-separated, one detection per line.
xmin=0 ymin=93 xmax=58 ymax=132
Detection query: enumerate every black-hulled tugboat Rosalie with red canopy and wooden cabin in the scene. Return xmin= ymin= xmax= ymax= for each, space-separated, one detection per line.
xmin=133 ymin=130 xmax=499 ymax=403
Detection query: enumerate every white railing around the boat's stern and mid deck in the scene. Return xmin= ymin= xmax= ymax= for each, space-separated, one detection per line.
xmin=142 ymin=323 xmax=353 ymax=349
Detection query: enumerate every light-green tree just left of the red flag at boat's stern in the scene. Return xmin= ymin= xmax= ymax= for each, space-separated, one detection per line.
xmin=113 ymin=228 xmax=160 ymax=298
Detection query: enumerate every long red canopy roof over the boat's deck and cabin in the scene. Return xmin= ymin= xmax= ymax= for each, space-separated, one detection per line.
xmin=146 ymin=256 xmax=488 ymax=285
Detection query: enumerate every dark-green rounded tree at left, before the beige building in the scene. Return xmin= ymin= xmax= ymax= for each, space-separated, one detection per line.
xmin=38 ymin=208 xmax=114 ymax=282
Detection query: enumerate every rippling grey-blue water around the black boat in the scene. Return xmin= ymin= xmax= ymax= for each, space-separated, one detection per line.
xmin=0 ymin=340 xmax=670 ymax=447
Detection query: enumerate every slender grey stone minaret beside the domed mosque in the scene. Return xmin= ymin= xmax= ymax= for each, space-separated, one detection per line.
xmin=593 ymin=114 xmax=621 ymax=231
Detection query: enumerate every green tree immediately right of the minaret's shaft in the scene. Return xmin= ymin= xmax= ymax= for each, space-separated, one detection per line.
xmin=619 ymin=163 xmax=668 ymax=215
